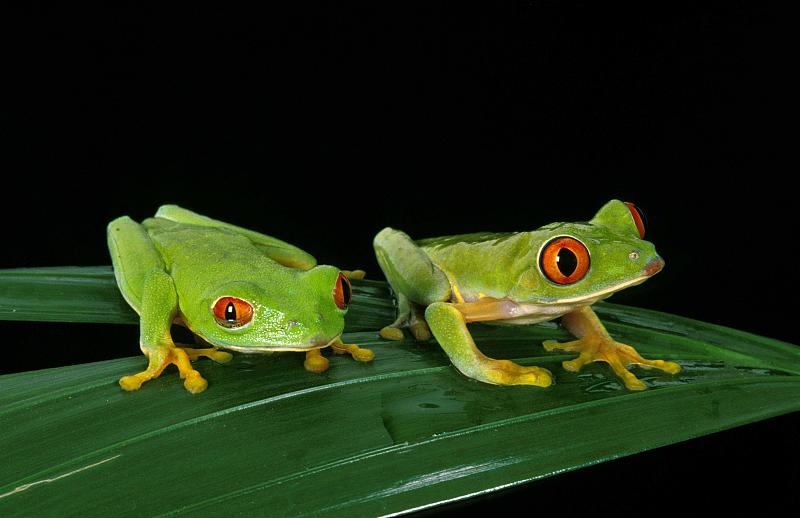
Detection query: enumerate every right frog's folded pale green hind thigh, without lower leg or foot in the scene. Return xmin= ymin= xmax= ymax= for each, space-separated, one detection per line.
xmin=373 ymin=227 xmax=450 ymax=306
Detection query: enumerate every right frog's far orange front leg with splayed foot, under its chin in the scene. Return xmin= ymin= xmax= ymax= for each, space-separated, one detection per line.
xmin=543 ymin=306 xmax=681 ymax=390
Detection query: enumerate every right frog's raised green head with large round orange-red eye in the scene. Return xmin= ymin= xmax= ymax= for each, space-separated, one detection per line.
xmin=512 ymin=200 xmax=664 ymax=307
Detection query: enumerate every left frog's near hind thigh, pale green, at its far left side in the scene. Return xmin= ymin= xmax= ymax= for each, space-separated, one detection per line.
xmin=106 ymin=216 xmax=164 ymax=313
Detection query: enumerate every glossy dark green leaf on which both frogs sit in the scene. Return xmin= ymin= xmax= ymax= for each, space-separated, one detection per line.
xmin=0 ymin=268 xmax=800 ymax=517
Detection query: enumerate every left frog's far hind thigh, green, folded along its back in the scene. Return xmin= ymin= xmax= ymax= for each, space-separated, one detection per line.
xmin=156 ymin=205 xmax=317 ymax=270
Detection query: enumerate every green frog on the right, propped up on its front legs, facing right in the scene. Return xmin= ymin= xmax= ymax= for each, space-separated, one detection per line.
xmin=373 ymin=199 xmax=681 ymax=391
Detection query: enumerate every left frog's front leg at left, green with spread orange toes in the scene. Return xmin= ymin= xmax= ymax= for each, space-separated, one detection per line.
xmin=119 ymin=270 xmax=208 ymax=394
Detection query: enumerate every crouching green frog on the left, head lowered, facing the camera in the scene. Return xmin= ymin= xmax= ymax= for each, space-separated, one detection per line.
xmin=106 ymin=205 xmax=374 ymax=394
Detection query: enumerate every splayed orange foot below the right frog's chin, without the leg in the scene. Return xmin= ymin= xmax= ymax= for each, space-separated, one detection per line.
xmin=542 ymin=334 xmax=681 ymax=390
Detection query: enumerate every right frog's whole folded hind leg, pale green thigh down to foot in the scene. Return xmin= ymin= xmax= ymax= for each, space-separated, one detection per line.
xmin=373 ymin=228 xmax=450 ymax=340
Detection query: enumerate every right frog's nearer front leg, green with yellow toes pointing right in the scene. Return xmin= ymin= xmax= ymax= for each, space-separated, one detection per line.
xmin=425 ymin=302 xmax=553 ymax=387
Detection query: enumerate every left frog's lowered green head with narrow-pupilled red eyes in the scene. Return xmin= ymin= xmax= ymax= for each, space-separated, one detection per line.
xmin=191 ymin=266 xmax=352 ymax=352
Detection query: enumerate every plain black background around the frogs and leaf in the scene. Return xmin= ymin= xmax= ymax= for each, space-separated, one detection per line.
xmin=0 ymin=1 xmax=800 ymax=514
